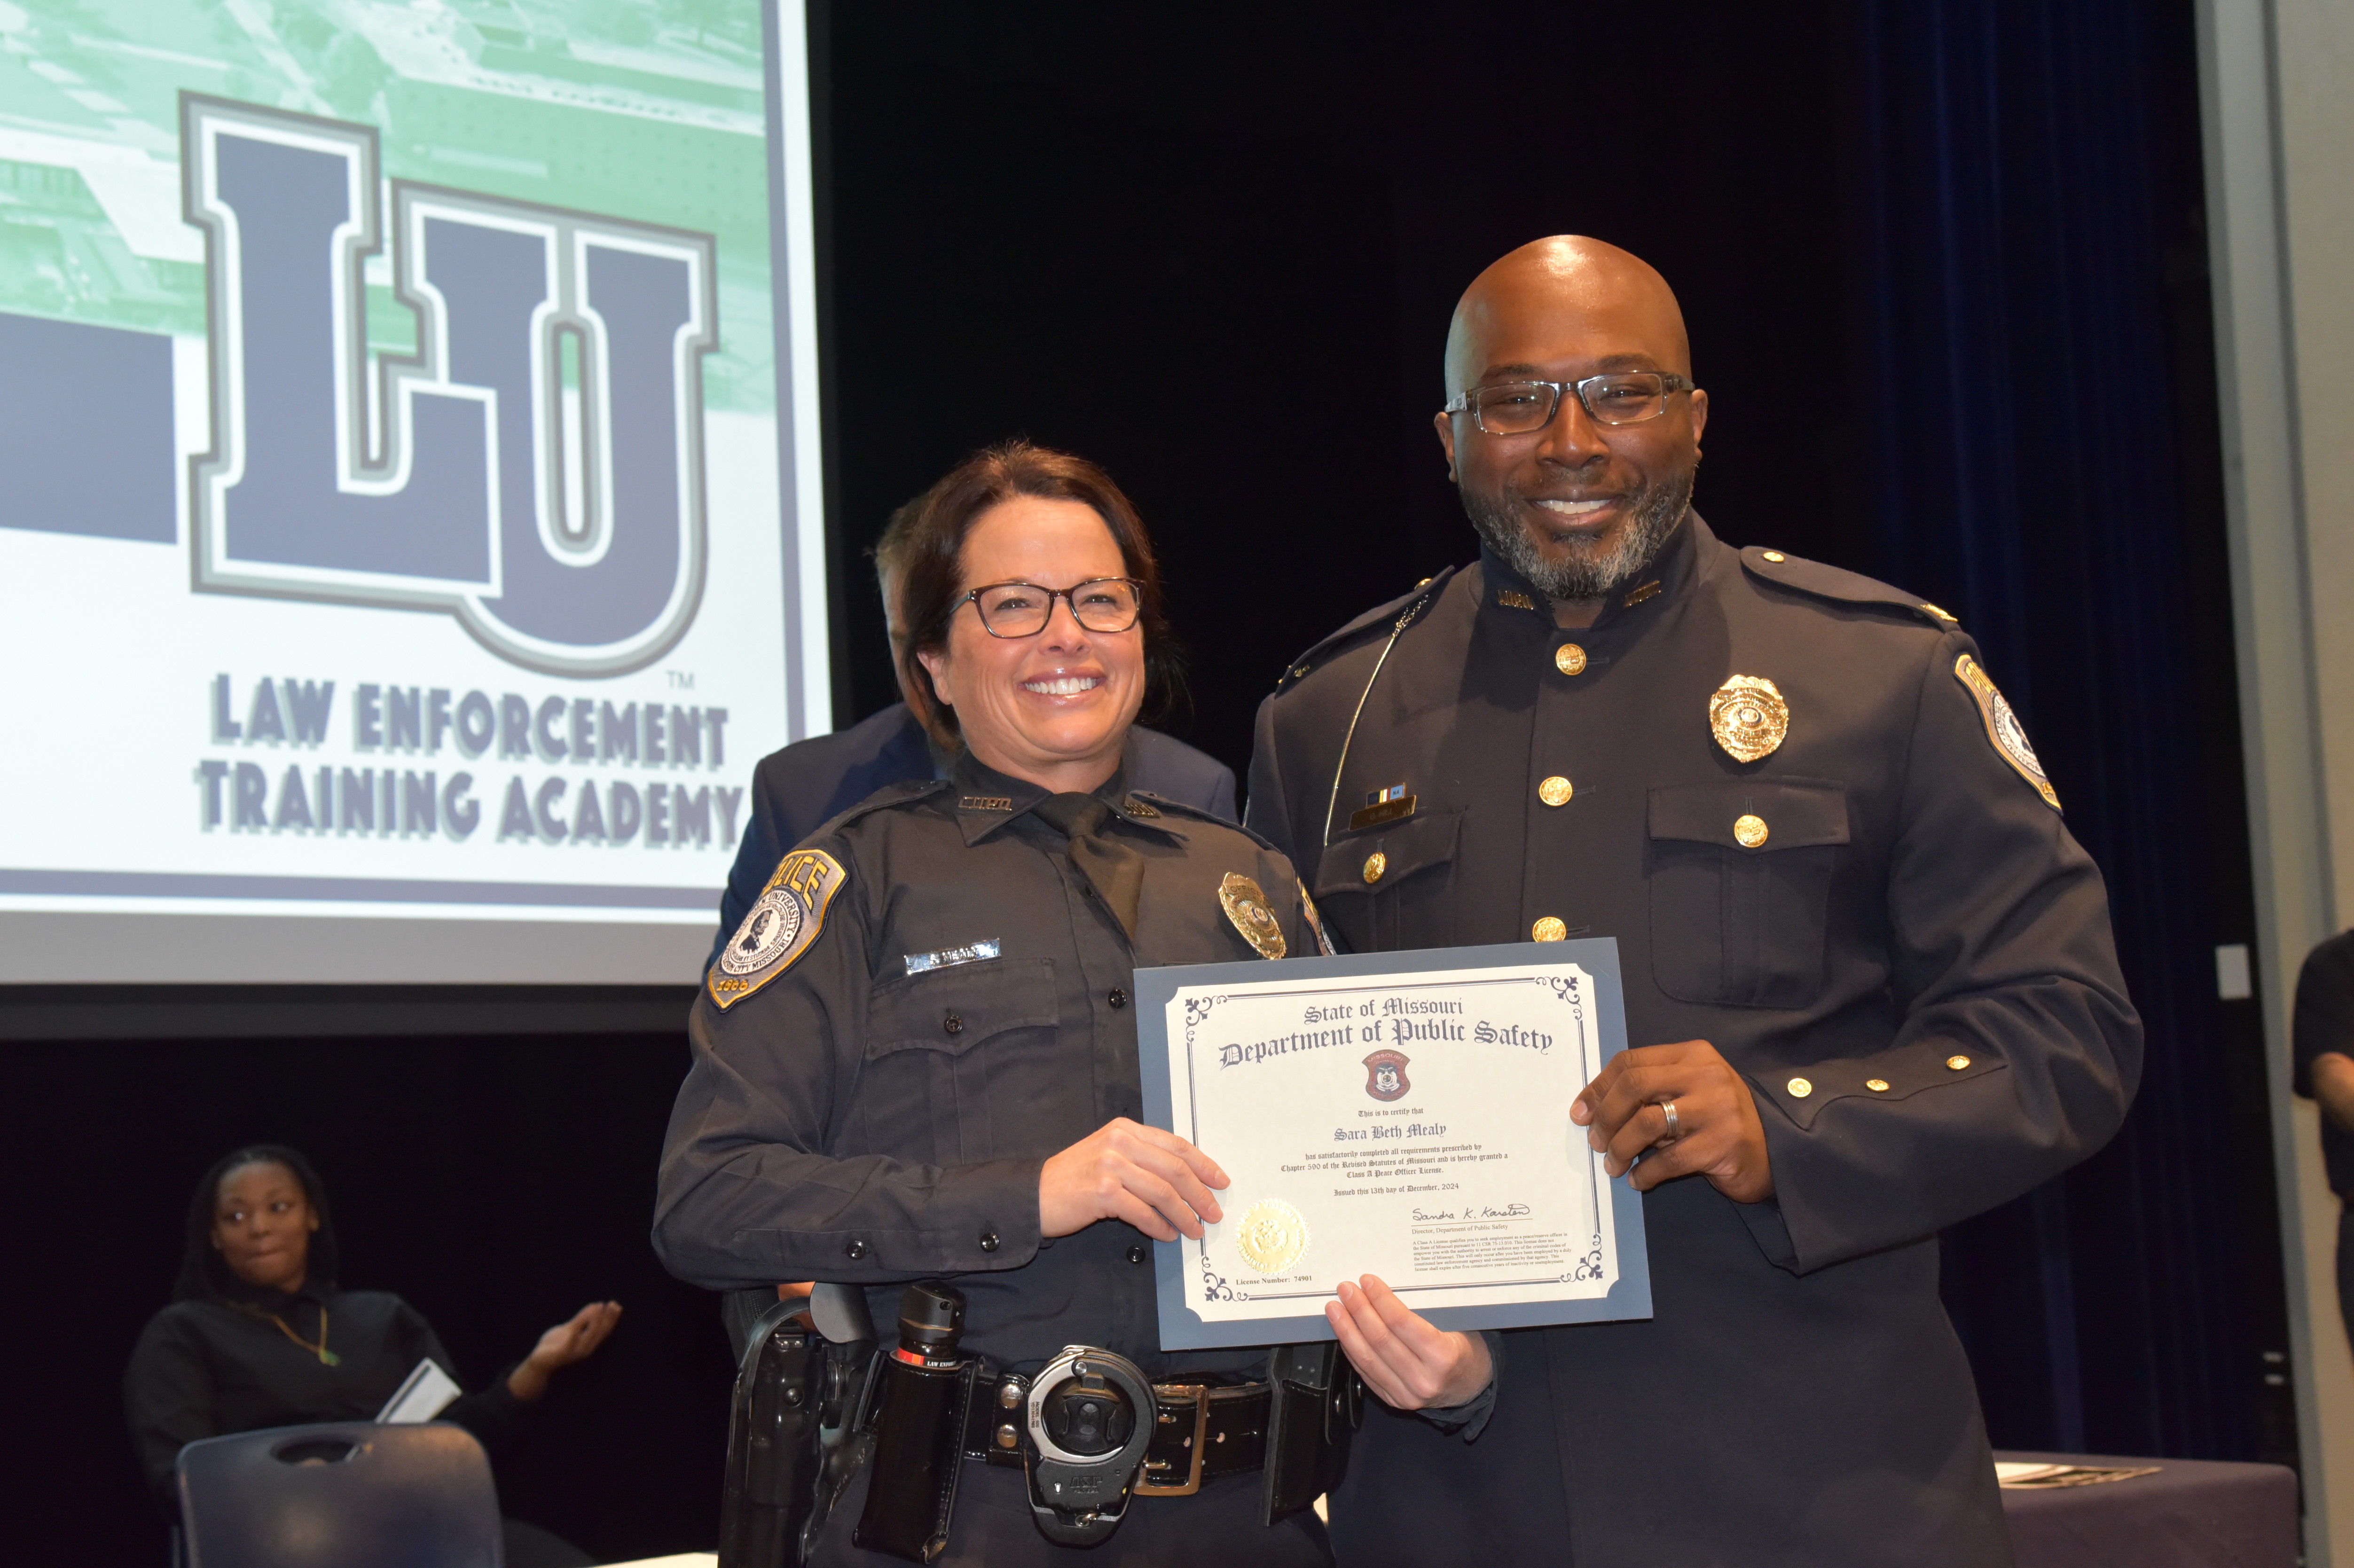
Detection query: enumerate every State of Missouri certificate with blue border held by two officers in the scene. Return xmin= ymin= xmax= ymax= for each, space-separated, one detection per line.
xmin=1137 ymin=937 xmax=1650 ymax=1349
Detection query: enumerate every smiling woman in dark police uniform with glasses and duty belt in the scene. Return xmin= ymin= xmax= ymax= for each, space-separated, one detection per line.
xmin=654 ymin=445 xmax=1488 ymax=1563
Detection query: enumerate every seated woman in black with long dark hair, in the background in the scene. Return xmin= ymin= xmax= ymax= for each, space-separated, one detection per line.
xmin=122 ymin=1144 xmax=621 ymax=1568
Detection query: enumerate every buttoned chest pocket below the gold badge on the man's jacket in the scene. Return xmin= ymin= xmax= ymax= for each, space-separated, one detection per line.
xmin=1650 ymin=779 xmax=1848 ymax=1008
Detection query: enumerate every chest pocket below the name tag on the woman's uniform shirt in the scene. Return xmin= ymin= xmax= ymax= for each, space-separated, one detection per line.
xmin=859 ymin=958 xmax=1059 ymax=1165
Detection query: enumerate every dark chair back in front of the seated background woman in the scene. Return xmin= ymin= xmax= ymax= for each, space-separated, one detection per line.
xmin=179 ymin=1422 xmax=504 ymax=1568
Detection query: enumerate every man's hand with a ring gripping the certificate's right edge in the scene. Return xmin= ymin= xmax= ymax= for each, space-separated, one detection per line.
xmin=1570 ymin=1041 xmax=1773 ymax=1203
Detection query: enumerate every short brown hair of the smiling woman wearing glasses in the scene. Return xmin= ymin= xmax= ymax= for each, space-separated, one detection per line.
xmin=895 ymin=440 xmax=1184 ymax=742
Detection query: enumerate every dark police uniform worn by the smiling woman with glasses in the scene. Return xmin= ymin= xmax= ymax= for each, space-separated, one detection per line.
xmin=654 ymin=756 xmax=1326 ymax=1561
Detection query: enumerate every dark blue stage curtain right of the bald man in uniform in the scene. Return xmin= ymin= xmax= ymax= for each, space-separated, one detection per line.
xmin=1857 ymin=0 xmax=2286 ymax=1460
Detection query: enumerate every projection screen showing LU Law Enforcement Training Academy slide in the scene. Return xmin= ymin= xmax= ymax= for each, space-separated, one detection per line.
xmin=0 ymin=0 xmax=831 ymax=982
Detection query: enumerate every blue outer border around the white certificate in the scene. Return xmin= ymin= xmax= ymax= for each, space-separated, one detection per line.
xmin=1135 ymin=937 xmax=1650 ymax=1351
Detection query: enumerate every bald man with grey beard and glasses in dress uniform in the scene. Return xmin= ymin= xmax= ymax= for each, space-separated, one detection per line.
xmin=1248 ymin=238 xmax=2142 ymax=1568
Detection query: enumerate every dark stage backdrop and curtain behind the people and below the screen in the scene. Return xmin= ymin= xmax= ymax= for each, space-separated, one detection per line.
xmin=0 ymin=0 xmax=2293 ymax=1563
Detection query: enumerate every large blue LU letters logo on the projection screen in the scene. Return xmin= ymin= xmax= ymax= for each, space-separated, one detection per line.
xmin=181 ymin=94 xmax=718 ymax=676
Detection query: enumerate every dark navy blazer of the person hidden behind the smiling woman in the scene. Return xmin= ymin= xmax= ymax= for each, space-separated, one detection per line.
xmin=704 ymin=702 xmax=1236 ymax=968
